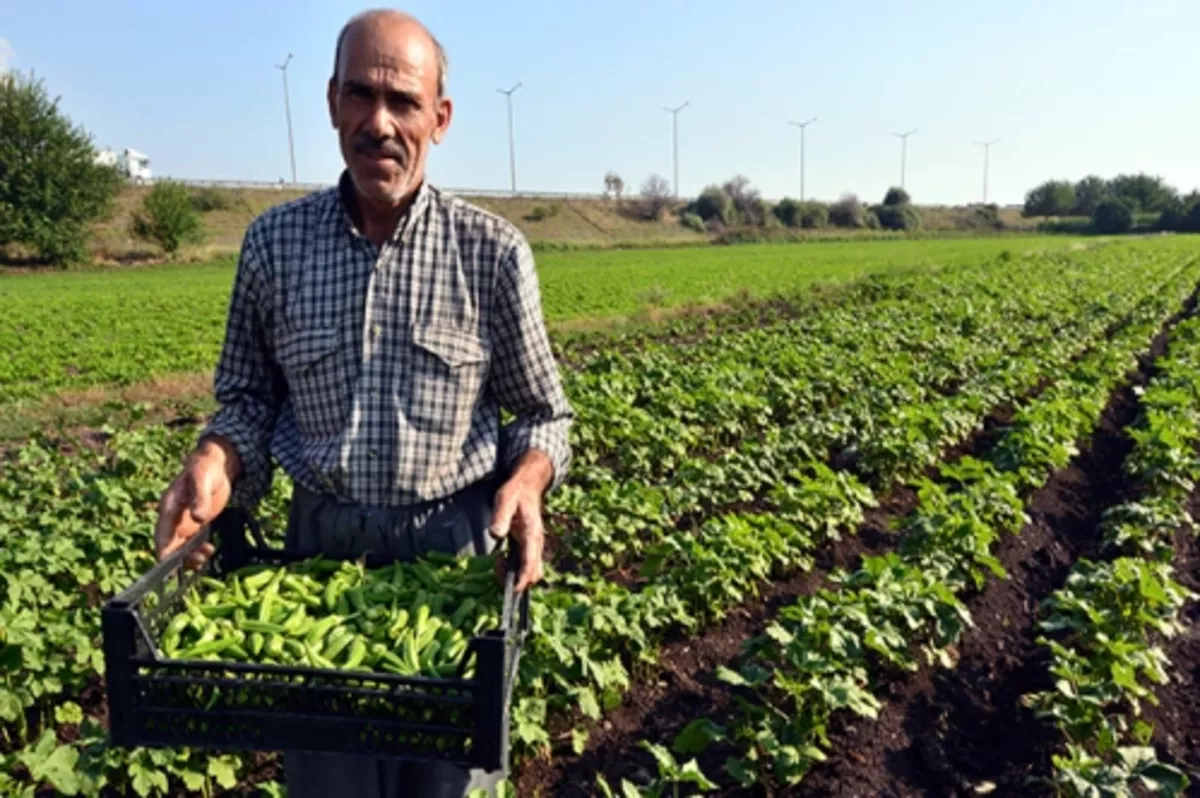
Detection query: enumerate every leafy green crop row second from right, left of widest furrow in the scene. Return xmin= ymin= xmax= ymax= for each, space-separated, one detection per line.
xmin=667 ymin=256 xmax=1198 ymax=784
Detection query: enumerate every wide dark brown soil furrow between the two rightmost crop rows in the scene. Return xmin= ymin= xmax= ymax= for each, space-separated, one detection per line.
xmin=796 ymin=304 xmax=1190 ymax=797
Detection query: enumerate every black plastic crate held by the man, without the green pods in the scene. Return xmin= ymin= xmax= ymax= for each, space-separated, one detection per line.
xmin=102 ymin=509 xmax=529 ymax=770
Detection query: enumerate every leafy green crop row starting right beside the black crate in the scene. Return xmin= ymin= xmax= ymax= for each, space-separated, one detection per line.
xmin=514 ymin=252 xmax=1196 ymax=758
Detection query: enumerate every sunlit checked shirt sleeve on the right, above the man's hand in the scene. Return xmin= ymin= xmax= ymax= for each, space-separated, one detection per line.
xmin=491 ymin=239 xmax=574 ymax=487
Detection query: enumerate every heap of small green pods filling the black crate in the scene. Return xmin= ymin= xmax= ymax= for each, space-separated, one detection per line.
xmin=158 ymin=554 xmax=502 ymax=678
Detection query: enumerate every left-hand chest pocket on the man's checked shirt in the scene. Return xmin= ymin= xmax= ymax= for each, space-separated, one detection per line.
xmin=275 ymin=326 xmax=348 ymax=437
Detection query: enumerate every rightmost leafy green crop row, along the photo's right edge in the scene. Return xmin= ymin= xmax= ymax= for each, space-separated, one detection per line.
xmin=1026 ymin=318 xmax=1200 ymax=796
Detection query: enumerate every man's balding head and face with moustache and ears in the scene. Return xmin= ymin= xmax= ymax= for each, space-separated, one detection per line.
xmin=329 ymin=17 xmax=451 ymax=208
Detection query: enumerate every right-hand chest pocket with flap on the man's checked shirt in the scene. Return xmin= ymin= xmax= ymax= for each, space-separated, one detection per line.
xmin=402 ymin=324 xmax=490 ymax=443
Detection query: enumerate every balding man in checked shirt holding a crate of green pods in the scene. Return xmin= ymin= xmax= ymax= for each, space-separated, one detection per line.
xmin=156 ymin=11 xmax=571 ymax=798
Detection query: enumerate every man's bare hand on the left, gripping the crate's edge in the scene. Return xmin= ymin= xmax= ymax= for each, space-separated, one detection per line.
xmin=154 ymin=437 xmax=241 ymax=568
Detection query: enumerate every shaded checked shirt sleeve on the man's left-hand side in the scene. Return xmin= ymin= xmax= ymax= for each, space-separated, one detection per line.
xmin=200 ymin=226 xmax=287 ymax=508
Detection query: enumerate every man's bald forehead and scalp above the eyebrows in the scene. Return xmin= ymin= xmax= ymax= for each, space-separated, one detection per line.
xmin=338 ymin=20 xmax=438 ymax=95
